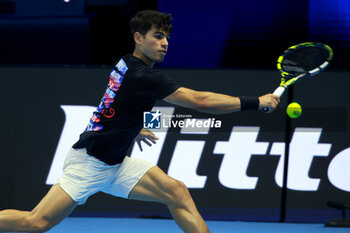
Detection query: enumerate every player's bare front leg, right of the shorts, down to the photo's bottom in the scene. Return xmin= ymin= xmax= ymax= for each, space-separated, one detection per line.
xmin=129 ymin=167 xmax=209 ymax=233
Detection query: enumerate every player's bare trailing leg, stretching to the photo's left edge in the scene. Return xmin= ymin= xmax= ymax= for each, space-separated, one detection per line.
xmin=0 ymin=184 xmax=77 ymax=232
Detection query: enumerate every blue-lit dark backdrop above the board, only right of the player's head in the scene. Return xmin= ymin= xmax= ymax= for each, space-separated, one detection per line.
xmin=158 ymin=0 xmax=350 ymax=68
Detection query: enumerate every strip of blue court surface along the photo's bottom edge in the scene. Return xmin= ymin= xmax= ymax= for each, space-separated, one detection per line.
xmin=49 ymin=217 xmax=350 ymax=233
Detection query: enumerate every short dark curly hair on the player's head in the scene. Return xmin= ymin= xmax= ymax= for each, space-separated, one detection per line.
xmin=130 ymin=10 xmax=173 ymax=36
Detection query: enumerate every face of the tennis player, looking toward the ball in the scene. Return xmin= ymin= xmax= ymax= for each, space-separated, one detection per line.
xmin=140 ymin=27 xmax=169 ymax=64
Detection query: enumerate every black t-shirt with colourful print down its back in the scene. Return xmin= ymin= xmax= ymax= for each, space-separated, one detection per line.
xmin=73 ymin=54 xmax=179 ymax=165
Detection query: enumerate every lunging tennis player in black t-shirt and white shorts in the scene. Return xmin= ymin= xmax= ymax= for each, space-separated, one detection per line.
xmin=0 ymin=10 xmax=279 ymax=233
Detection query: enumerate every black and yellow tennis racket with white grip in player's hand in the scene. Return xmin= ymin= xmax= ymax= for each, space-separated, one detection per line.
xmin=263 ymin=42 xmax=333 ymax=112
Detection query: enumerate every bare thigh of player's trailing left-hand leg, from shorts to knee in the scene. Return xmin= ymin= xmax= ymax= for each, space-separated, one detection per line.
xmin=31 ymin=184 xmax=77 ymax=225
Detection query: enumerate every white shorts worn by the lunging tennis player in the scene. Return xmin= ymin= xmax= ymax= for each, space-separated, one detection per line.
xmin=57 ymin=148 xmax=155 ymax=205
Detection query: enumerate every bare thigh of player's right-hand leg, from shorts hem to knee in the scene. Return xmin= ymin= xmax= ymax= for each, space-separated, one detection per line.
xmin=129 ymin=166 xmax=187 ymax=203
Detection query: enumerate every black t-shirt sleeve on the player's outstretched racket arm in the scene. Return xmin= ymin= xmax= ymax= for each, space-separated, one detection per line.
xmin=137 ymin=71 xmax=180 ymax=100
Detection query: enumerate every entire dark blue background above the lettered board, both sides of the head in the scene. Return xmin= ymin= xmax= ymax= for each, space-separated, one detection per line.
xmin=0 ymin=0 xmax=350 ymax=69
